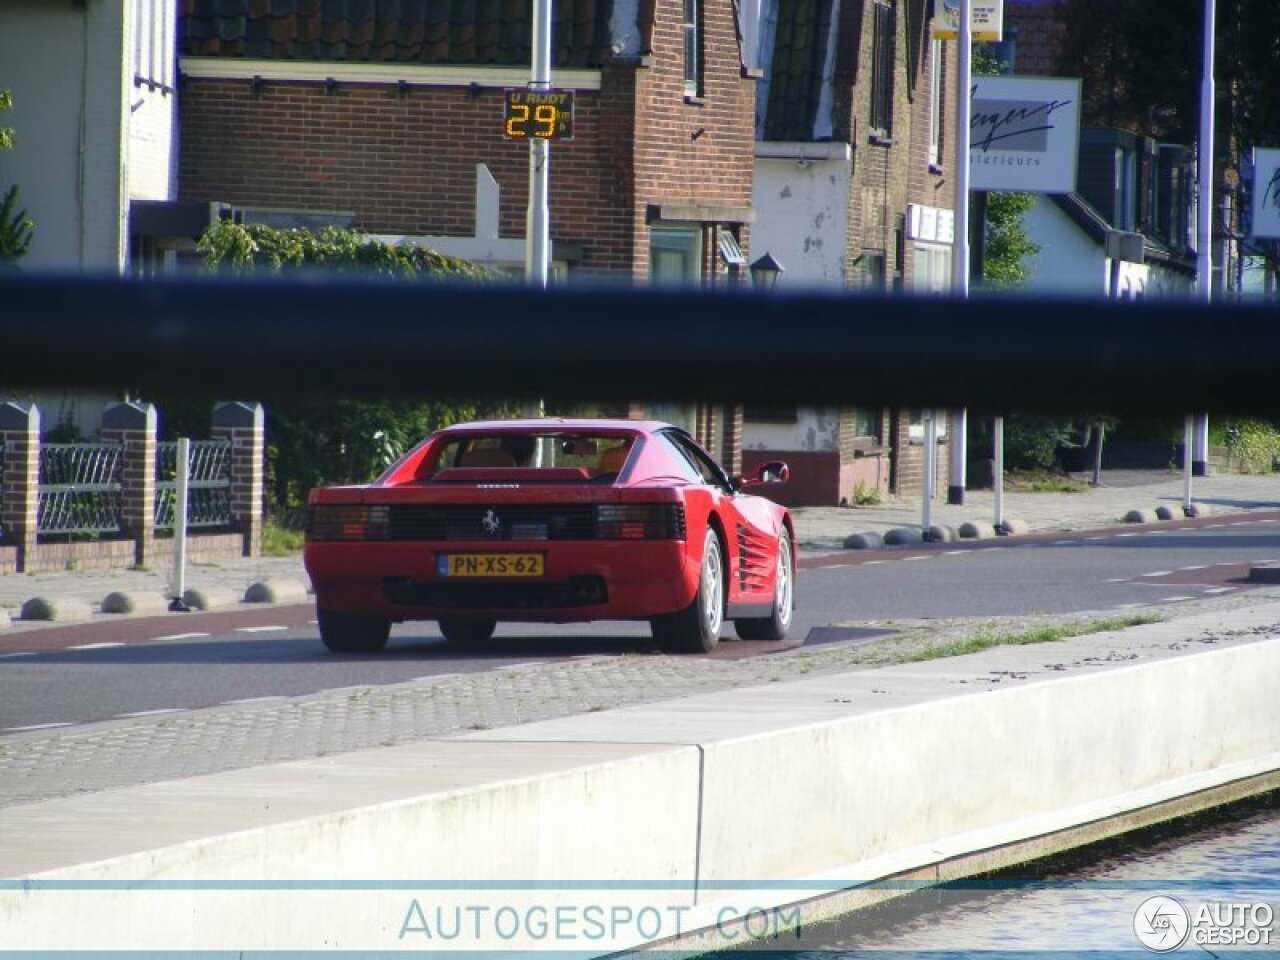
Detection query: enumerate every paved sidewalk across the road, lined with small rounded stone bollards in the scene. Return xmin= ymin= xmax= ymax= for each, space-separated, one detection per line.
xmin=0 ymin=471 xmax=1280 ymax=630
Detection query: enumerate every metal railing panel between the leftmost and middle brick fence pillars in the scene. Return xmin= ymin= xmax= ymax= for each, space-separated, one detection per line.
xmin=36 ymin=443 xmax=124 ymax=535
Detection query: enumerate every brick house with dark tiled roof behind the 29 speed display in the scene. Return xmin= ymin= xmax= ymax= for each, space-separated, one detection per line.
xmin=170 ymin=0 xmax=755 ymax=463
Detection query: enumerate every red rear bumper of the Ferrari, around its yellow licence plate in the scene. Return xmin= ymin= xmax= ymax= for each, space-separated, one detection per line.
xmin=303 ymin=540 xmax=698 ymax=622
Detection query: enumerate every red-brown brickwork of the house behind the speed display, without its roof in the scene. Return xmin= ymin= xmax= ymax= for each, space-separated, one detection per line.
xmin=179 ymin=0 xmax=754 ymax=279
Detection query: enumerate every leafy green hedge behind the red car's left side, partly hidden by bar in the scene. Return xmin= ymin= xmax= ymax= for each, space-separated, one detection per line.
xmin=152 ymin=221 xmax=515 ymax=518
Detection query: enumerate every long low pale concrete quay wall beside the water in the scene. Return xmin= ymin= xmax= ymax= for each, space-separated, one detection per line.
xmin=0 ymin=624 xmax=1280 ymax=954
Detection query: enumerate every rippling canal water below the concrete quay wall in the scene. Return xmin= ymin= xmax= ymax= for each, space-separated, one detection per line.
xmin=727 ymin=794 xmax=1280 ymax=960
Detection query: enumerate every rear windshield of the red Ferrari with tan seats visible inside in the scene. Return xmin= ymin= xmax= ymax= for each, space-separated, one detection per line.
xmin=428 ymin=433 xmax=632 ymax=483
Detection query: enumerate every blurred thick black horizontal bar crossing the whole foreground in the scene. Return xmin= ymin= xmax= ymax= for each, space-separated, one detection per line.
xmin=0 ymin=275 xmax=1280 ymax=413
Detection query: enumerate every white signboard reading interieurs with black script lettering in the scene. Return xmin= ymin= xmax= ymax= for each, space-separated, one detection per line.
xmin=969 ymin=77 xmax=1080 ymax=193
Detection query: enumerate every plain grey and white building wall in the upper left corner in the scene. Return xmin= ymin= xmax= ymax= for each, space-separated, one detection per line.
xmin=0 ymin=0 xmax=177 ymax=273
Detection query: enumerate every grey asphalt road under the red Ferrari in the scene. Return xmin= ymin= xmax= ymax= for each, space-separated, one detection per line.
xmin=0 ymin=520 xmax=1280 ymax=736
